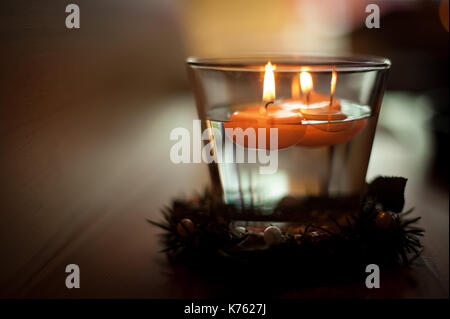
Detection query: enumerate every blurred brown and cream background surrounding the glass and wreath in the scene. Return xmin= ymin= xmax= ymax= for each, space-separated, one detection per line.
xmin=0 ymin=0 xmax=449 ymax=298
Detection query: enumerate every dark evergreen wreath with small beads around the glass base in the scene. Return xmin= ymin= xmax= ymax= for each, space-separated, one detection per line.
xmin=149 ymin=177 xmax=424 ymax=279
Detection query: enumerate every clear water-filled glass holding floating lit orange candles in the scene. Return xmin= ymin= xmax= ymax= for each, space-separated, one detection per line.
xmin=187 ymin=56 xmax=390 ymax=230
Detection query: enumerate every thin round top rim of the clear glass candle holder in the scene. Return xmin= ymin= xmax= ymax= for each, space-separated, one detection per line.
xmin=186 ymin=54 xmax=391 ymax=72
